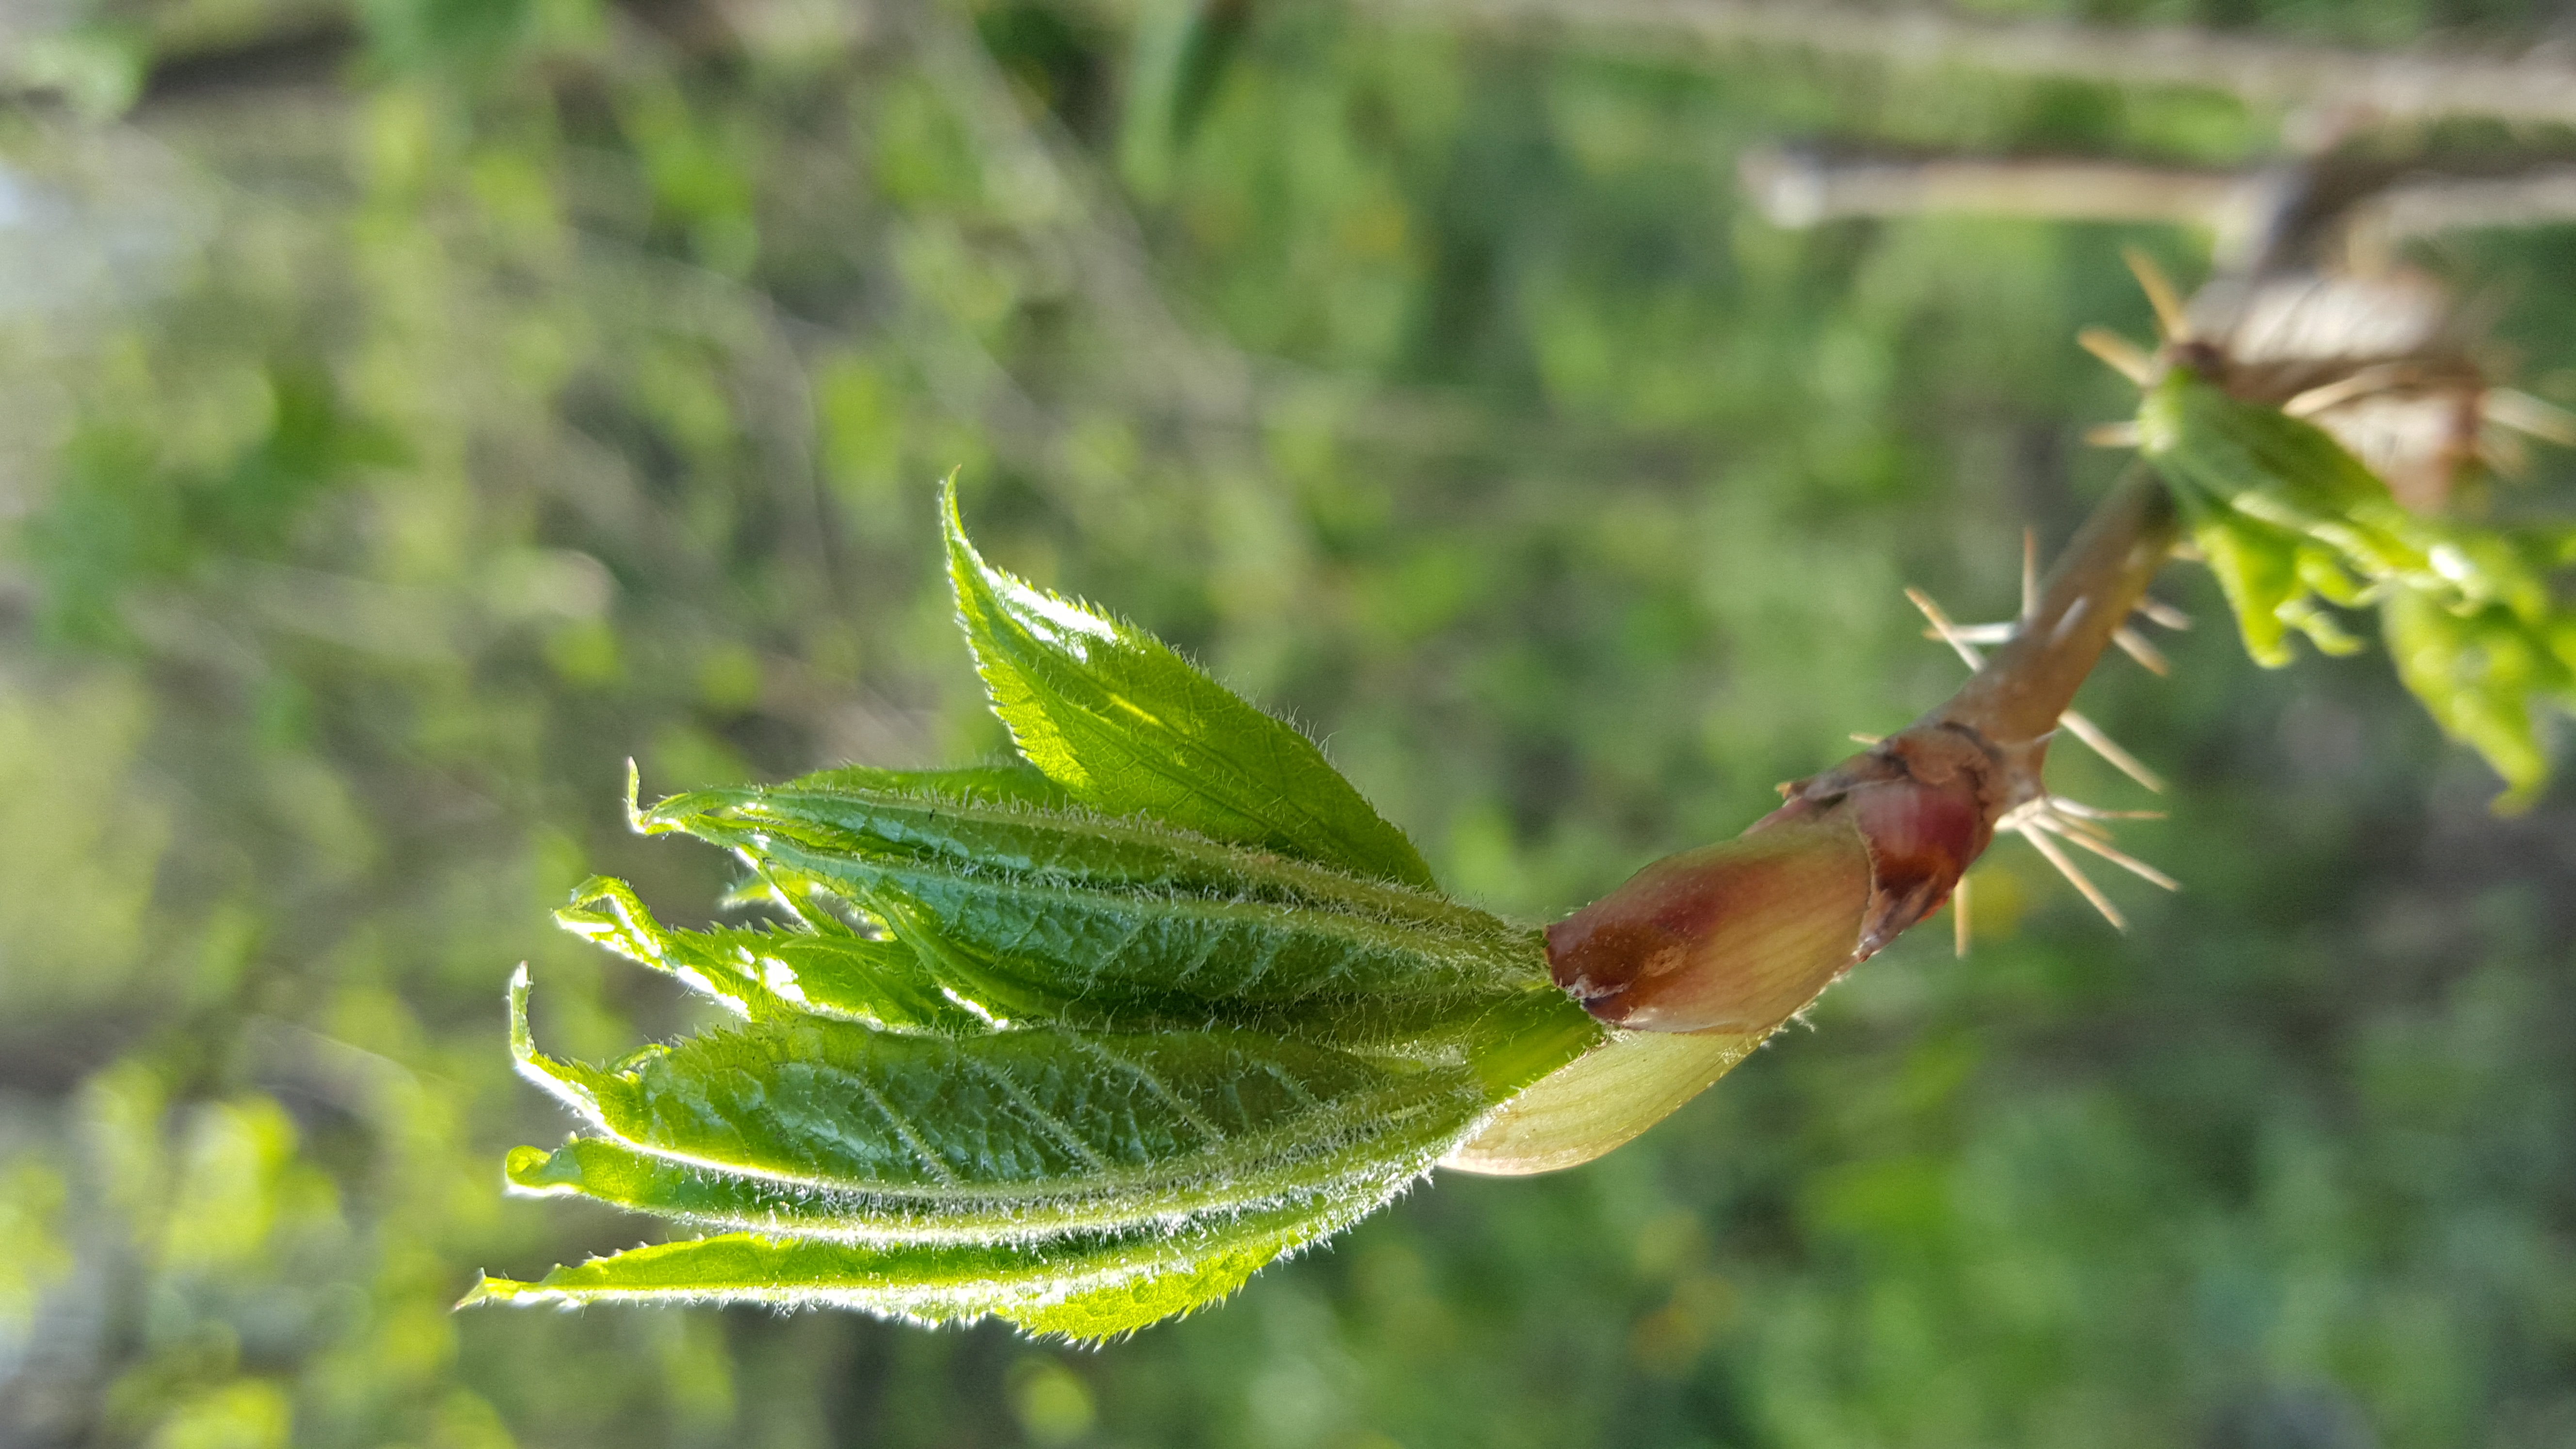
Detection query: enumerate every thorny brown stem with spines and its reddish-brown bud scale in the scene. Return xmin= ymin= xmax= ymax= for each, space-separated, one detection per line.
xmin=1548 ymin=467 xmax=2179 ymax=1042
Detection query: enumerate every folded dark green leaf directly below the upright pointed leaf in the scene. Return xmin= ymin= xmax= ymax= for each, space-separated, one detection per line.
xmin=639 ymin=787 xmax=1546 ymax=1026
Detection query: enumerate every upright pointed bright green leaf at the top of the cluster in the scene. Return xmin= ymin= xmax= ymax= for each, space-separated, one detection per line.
xmin=940 ymin=480 xmax=1435 ymax=889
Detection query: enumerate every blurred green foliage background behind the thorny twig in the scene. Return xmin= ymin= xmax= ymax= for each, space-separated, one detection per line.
xmin=0 ymin=0 xmax=2576 ymax=1449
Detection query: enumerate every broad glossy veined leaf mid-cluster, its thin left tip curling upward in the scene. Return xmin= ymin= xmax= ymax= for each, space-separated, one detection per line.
xmin=497 ymin=969 xmax=1587 ymax=1238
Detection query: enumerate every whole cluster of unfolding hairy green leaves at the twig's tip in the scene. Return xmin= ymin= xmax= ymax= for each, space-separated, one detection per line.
xmin=461 ymin=482 xmax=1600 ymax=1338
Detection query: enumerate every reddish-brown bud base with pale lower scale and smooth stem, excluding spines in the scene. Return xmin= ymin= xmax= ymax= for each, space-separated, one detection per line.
xmin=1473 ymin=474 xmax=2179 ymax=1173
